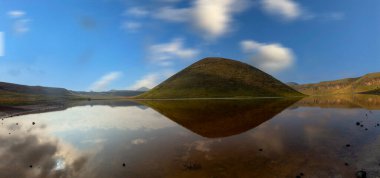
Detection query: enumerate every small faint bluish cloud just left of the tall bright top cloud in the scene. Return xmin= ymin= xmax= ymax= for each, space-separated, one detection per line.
xmin=154 ymin=7 xmax=191 ymax=22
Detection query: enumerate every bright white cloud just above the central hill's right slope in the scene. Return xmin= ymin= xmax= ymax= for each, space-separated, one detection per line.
xmin=240 ymin=40 xmax=295 ymax=72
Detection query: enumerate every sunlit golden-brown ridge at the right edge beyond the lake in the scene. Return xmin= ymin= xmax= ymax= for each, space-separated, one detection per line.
xmin=289 ymin=72 xmax=380 ymax=95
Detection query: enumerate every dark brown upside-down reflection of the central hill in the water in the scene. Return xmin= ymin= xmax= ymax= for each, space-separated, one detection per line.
xmin=142 ymin=98 xmax=300 ymax=138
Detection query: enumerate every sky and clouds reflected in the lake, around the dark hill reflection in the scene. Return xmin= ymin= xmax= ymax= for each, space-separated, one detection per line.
xmin=0 ymin=106 xmax=380 ymax=178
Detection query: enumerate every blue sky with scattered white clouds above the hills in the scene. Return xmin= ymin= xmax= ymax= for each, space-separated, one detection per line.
xmin=0 ymin=0 xmax=380 ymax=91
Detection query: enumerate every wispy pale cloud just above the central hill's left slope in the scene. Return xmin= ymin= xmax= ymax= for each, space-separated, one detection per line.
xmin=149 ymin=38 xmax=199 ymax=66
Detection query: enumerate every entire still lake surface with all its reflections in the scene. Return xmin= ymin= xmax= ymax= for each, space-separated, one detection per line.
xmin=0 ymin=95 xmax=380 ymax=178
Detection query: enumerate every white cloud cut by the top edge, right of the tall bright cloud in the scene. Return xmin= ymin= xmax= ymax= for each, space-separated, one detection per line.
xmin=261 ymin=0 xmax=302 ymax=20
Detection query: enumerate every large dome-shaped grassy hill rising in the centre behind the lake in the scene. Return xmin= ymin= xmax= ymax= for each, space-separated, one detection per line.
xmin=137 ymin=58 xmax=302 ymax=99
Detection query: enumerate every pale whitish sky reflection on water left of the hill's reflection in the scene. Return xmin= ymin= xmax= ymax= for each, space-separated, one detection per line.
xmin=8 ymin=106 xmax=175 ymax=147
